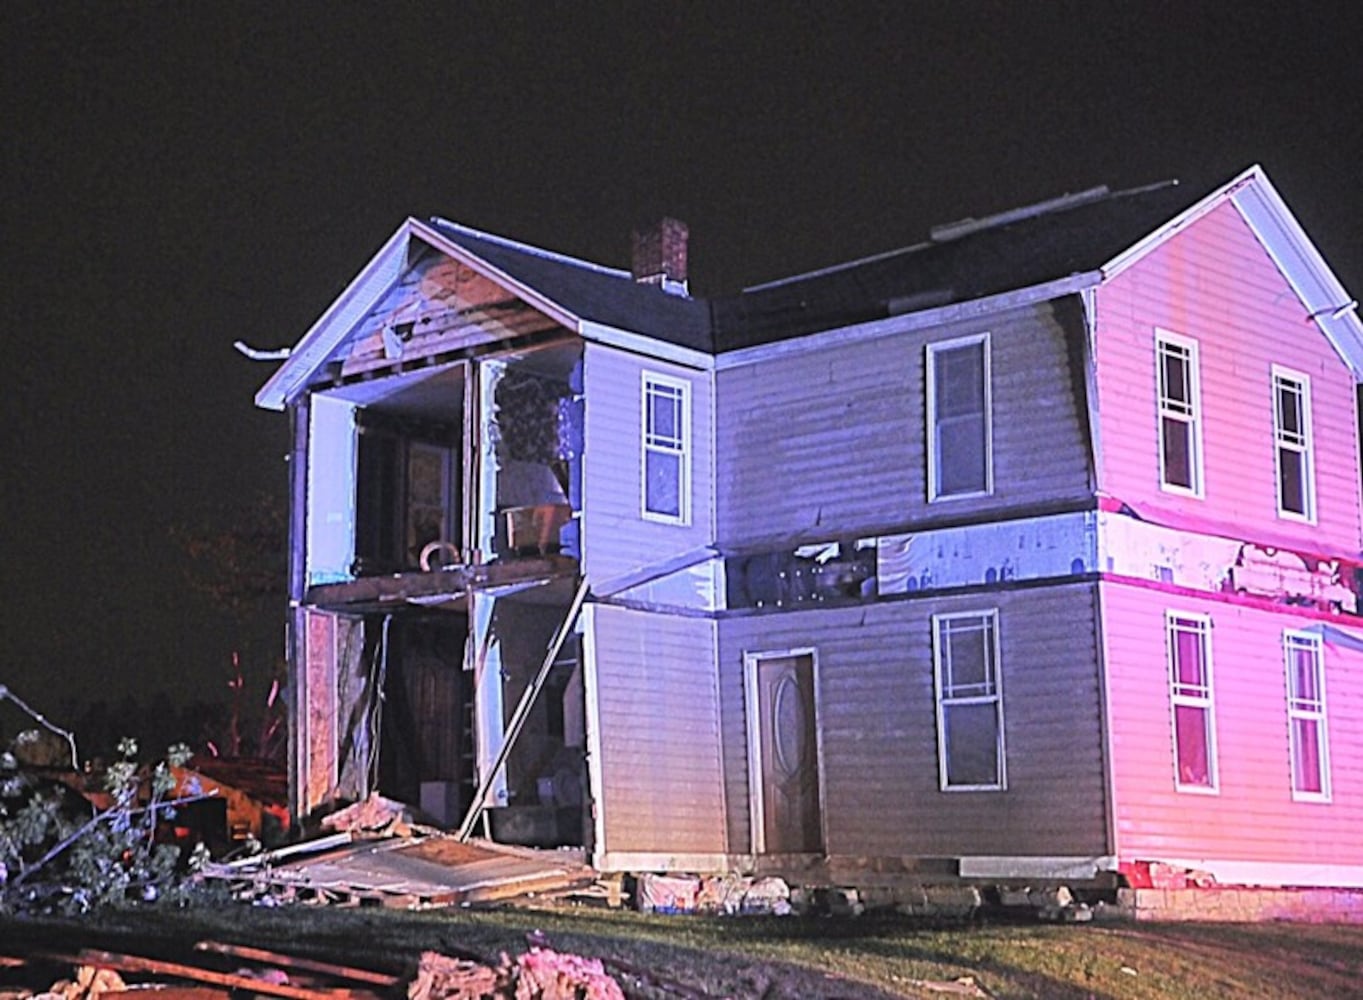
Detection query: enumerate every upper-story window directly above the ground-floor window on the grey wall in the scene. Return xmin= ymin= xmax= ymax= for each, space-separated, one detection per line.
xmin=927 ymin=334 xmax=994 ymax=500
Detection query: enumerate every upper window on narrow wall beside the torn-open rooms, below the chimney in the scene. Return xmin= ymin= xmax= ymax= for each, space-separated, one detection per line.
xmin=643 ymin=372 xmax=691 ymax=525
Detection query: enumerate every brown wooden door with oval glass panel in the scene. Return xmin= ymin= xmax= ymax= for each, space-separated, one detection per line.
xmin=750 ymin=653 xmax=823 ymax=854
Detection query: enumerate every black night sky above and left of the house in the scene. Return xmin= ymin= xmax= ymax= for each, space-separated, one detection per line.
xmin=0 ymin=0 xmax=1363 ymax=713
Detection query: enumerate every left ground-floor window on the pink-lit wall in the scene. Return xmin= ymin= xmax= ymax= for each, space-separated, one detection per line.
xmin=1165 ymin=612 xmax=1217 ymax=792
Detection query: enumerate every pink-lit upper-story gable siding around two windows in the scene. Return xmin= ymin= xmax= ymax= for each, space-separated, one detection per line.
xmin=1097 ymin=204 xmax=1360 ymax=552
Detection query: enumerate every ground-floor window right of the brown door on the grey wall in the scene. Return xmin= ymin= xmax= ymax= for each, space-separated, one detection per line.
xmin=932 ymin=610 xmax=1005 ymax=792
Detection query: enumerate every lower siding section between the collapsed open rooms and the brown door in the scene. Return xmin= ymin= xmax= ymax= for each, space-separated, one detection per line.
xmin=590 ymin=605 xmax=725 ymax=854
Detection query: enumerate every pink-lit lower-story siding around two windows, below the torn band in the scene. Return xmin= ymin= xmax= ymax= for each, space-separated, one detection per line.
xmin=1101 ymin=583 xmax=1363 ymax=873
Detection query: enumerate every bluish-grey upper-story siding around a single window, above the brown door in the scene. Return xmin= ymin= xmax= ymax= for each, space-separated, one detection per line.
xmin=716 ymin=302 xmax=1088 ymax=545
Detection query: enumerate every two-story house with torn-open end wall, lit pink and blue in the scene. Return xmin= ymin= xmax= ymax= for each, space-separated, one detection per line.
xmin=258 ymin=168 xmax=1363 ymax=886
